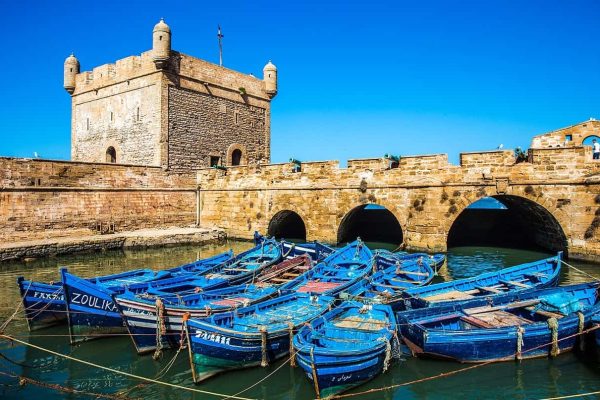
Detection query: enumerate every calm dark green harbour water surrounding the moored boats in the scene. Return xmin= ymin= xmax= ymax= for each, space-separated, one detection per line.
xmin=0 ymin=242 xmax=600 ymax=400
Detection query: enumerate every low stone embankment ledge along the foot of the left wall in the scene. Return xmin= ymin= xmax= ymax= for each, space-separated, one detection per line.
xmin=0 ymin=227 xmax=226 ymax=261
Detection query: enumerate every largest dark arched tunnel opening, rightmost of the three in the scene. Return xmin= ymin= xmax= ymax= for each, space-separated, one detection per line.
xmin=447 ymin=195 xmax=568 ymax=255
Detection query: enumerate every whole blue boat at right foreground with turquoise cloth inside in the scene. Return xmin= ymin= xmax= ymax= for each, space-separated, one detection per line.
xmin=397 ymin=282 xmax=600 ymax=363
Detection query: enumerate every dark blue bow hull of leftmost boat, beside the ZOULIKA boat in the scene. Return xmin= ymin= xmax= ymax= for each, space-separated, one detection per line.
xmin=17 ymin=277 xmax=67 ymax=331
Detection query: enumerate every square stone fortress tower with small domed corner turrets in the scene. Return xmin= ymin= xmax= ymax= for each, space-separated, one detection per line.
xmin=64 ymin=20 xmax=277 ymax=170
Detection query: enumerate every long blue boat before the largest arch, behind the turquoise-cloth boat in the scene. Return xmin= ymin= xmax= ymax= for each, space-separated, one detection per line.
xmin=390 ymin=252 xmax=562 ymax=309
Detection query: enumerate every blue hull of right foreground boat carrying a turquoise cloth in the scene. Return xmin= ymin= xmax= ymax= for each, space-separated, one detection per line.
xmin=397 ymin=283 xmax=600 ymax=363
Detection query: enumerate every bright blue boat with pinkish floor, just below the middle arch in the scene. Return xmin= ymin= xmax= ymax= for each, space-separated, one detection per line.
xmin=281 ymin=240 xmax=373 ymax=296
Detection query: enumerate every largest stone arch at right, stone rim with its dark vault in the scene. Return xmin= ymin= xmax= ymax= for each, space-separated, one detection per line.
xmin=446 ymin=195 xmax=569 ymax=252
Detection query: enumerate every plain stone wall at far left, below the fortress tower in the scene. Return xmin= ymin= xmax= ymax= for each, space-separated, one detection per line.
xmin=0 ymin=158 xmax=196 ymax=241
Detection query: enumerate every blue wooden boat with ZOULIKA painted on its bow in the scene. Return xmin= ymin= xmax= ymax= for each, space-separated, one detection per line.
xmin=61 ymin=241 xmax=281 ymax=343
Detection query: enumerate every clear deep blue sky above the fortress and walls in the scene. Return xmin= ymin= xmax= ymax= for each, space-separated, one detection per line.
xmin=0 ymin=0 xmax=600 ymax=162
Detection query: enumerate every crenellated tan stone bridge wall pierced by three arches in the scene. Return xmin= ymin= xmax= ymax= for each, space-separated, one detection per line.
xmin=198 ymin=147 xmax=600 ymax=258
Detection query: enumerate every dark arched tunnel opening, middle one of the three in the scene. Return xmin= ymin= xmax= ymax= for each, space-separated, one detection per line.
xmin=337 ymin=204 xmax=403 ymax=247
